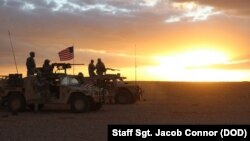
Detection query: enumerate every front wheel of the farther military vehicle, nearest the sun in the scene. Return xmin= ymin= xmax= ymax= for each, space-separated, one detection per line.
xmin=115 ymin=89 xmax=132 ymax=104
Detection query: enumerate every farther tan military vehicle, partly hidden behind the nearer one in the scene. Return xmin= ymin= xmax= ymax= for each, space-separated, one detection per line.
xmin=85 ymin=72 xmax=143 ymax=104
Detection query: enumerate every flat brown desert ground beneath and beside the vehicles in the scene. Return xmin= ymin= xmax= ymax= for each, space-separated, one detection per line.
xmin=0 ymin=82 xmax=250 ymax=141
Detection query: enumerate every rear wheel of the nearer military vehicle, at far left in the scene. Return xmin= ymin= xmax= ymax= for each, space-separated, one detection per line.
xmin=8 ymin=94 xmax=25 ymax=113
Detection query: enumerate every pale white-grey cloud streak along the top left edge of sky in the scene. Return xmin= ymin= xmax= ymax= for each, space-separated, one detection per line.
xmin=0 ymin=0 xmax=131 ymax=14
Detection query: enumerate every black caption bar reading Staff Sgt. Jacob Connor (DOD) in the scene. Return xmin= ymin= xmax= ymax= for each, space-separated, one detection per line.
xmin=108 ymin=125 xmax=250 ymax=141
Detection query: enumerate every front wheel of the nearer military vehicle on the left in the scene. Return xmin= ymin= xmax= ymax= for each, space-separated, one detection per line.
xmin=70 ymin=94 xmax=90 ymax=113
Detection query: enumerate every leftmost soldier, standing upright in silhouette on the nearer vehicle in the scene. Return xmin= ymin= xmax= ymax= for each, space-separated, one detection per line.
xmin=26 ymin=51 xmax=36 ymax=76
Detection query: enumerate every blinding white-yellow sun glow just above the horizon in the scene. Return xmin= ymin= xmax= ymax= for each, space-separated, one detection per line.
xmin=143 ymin=49 xmax=246 ymax=81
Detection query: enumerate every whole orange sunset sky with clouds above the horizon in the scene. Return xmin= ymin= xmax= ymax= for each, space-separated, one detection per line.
xmin=0 ymin=0 xmax=250 ymax=81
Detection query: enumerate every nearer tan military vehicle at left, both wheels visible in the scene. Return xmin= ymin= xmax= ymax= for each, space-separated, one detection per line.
xmin=0 ymin=63 xmax=104 ymax=113
